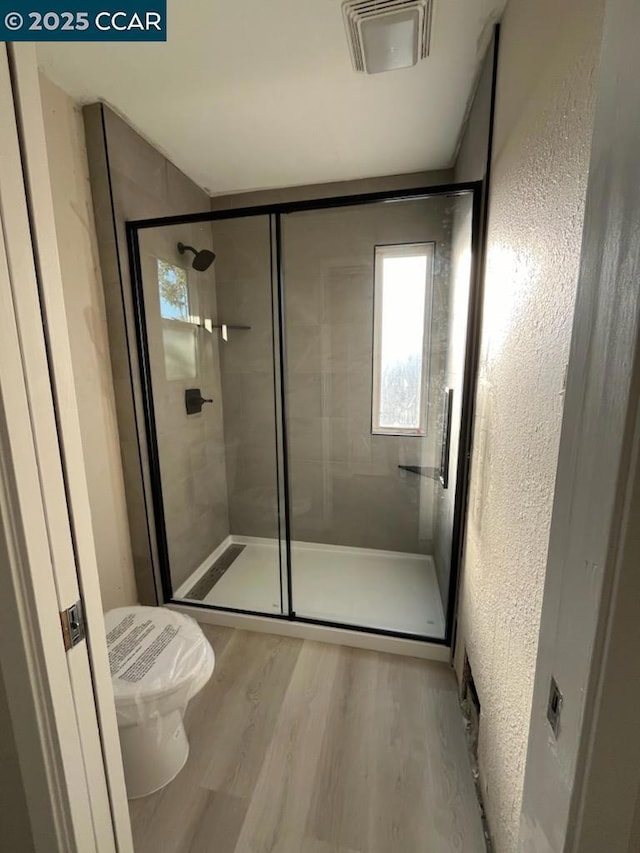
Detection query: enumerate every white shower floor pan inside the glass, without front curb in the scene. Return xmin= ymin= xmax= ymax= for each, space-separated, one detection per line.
xmin=174 ymin=536 xmax=445 ymax=638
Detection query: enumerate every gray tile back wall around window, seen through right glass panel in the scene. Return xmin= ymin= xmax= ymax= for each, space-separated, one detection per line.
xmin=283 ymin=197 xmax=454 ymax=554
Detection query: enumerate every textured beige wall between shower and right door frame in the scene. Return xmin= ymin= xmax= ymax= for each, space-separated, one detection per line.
xmin=458 ymin=0 xmax=603 ymax=853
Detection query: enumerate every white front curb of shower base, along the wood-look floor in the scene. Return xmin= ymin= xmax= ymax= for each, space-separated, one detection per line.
xmin=166 ymin=604 xmax=451 ymax=664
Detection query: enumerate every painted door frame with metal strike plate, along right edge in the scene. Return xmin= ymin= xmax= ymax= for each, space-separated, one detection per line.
xmin=520 ymin=0 xmax=640 ymax=853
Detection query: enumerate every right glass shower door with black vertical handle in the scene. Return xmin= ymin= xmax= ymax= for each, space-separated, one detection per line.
xmin=282 ymin=190 xmax=472 ymax=640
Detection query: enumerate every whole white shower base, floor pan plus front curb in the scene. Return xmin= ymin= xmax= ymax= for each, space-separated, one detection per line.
xmin=171 ymin=535 xmax=449 ymax=661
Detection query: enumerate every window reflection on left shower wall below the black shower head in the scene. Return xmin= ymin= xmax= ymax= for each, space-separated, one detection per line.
xmin=157 ymin=258 xmax=198 ymax=381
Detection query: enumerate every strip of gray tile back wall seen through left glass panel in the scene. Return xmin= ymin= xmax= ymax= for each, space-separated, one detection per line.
xmin=212 ymin=216 xmax=279 ymax=539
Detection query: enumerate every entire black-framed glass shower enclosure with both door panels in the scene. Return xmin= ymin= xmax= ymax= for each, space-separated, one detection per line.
xmin=128 ymin=184 xmax=479 ymax=643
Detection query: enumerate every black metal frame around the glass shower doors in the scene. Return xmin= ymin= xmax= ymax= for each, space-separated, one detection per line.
xmin=126 ymin=181 xmax=483 ymax=646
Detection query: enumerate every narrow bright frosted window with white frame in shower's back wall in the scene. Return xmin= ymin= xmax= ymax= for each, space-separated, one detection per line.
xmin=372 ymin=243 xmax=434 ymax=435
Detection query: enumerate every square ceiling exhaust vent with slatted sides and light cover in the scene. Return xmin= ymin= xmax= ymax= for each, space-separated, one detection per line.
xmin=342 ymin=0 xmax=433 ymax=74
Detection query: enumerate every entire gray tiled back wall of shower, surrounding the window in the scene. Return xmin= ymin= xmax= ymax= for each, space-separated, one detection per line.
xmin=205 ymin=192 xmax=453 ymax=553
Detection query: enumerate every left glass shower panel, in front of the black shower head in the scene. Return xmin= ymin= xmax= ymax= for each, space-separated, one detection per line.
xmin=138 ymin=216 xmax=287 ymax=616
